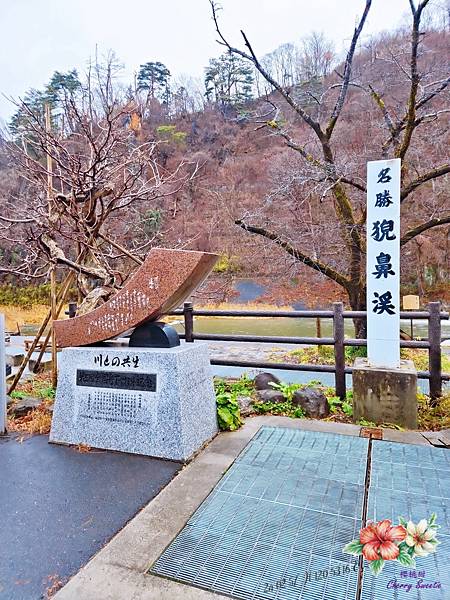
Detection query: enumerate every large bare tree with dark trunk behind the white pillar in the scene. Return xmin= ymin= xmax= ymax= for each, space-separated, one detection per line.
xmin=210 ymin=0 xmax=450 ymax=336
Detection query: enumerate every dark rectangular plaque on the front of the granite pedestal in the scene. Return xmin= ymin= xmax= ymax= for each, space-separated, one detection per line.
xmin=77 ymin=369 xmax=156 ymax=392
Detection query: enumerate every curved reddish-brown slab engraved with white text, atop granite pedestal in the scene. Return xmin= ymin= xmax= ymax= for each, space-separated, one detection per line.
xmin=54 ymin=248 xmax=218 ymax=348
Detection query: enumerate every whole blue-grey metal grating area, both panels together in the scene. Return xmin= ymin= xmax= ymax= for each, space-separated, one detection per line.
xmin=150 ymin=427 xmax=450 ymax=600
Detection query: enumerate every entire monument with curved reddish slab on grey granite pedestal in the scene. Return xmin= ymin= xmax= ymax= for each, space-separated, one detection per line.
xmin=50 ymin=249 xmax=217 ymax=461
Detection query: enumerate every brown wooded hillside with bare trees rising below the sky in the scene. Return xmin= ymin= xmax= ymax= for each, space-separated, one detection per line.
xmin=0 ymin=11 xmax=450 ymax=307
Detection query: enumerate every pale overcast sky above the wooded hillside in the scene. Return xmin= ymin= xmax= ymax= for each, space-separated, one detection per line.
xmin=0 ymin=0 xmax=409 ymax=119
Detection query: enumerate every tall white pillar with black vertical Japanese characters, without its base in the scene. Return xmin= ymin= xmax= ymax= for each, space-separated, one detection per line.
xmin=367 ymin=158 xmax=401 ymax=368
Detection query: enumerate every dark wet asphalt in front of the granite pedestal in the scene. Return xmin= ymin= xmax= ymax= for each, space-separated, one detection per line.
xmin=0 ymin=436 xmax=181 ymax=600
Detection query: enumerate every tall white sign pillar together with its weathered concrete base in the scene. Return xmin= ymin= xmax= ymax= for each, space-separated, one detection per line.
xmin=353 ymin=158 xmax=417 ymax=429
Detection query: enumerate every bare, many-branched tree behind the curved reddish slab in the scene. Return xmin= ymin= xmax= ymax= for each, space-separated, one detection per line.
xmin=0 ymin=56 xmax=196 ymax=311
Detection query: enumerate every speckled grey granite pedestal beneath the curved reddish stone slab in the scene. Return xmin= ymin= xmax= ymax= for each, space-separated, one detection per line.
xmin=50 ymin=342 xmax=217 ymax=461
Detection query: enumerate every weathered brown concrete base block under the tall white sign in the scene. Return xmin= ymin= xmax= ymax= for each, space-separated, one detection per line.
xmin=353 ymin=358 xmax=417 ymax=429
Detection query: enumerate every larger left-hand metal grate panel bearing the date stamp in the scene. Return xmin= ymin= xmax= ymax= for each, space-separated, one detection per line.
xmin=150 ymin=427 xmax=368 ymax=600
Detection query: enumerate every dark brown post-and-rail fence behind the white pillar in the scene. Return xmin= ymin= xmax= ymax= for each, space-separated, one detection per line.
xmin=169 ymin=302 xmax=450 ymax=400
